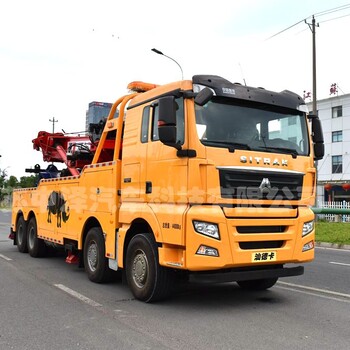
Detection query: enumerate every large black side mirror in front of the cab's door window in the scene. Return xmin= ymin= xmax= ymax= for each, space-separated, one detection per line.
xmin=158 ymin=96 xmax=179 ymax=149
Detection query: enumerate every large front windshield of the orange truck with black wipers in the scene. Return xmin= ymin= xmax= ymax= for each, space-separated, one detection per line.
xmin=195 ymin=97 xmax=309 ymax=155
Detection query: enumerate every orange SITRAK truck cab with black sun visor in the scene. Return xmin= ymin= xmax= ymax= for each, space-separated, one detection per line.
xmin=120 ymin=76 xmax=323 ymax=298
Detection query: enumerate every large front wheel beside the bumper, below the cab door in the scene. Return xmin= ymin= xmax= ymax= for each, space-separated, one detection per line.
xmin=125 ymin=234 xmax=174 ymax=302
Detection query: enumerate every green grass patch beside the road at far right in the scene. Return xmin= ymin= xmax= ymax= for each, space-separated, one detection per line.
xmin=316 ymin=221 xmax=350 ymax=245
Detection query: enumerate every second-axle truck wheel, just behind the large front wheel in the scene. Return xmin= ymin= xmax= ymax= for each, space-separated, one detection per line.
xmin=84 ymin=227 xmax=113 ymax=283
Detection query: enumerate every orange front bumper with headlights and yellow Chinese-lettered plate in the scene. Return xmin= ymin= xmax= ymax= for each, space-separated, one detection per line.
xmin=185 ymin=205 xmax=315 ymax=272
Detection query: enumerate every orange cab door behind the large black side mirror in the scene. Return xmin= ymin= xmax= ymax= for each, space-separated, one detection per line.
xmin=145 ymin=98 xmax=188 ymax=245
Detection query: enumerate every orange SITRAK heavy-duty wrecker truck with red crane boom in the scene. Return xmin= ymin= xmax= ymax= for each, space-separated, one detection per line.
xmin=10 ymin=75 xmax=324 ymax=302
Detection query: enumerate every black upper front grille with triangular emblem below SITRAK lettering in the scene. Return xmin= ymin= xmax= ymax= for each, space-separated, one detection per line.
xmin=219 ymin=168 xmax=304 ymax=201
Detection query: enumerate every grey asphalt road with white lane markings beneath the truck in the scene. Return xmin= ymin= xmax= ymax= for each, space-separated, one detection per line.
xmin=0 ymin=211 xmax=350 ymax=350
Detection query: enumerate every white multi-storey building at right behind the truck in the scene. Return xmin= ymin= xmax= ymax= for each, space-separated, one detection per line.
xmin=308 ymin=94 xmax=350 ymax=203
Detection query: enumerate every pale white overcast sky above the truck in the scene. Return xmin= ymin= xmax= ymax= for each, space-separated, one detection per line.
xmin=0 ymin=0 xmax=350 ymax=179
